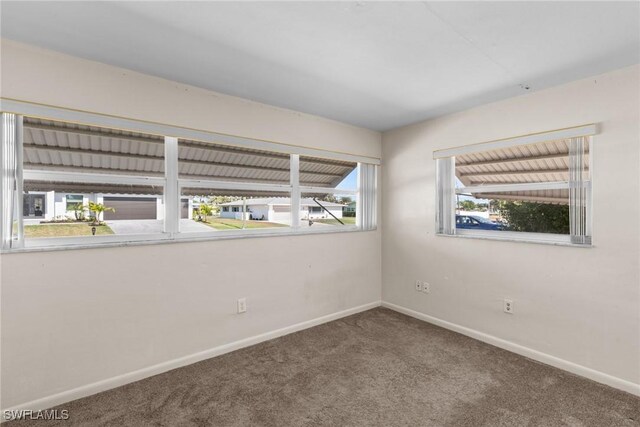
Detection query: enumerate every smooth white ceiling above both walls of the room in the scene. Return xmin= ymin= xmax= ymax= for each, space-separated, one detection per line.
xmin=0 ymin=1 xmax=640 ymax=130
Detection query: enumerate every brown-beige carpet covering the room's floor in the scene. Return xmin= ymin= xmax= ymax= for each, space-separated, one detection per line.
xmin=6 ymin=308 xmax=640 ymax=427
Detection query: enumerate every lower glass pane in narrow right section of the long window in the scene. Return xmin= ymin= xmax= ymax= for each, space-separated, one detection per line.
xmin=300 ymin=193 xmax=356 ymax=229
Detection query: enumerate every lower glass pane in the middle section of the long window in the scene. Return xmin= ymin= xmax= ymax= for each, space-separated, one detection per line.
xmin=180 ymin=188 xmax=291 ymax=233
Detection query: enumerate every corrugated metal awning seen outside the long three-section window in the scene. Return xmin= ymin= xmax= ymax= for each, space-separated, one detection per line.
xmin=24 ymin=117 xmax=357 ymax=194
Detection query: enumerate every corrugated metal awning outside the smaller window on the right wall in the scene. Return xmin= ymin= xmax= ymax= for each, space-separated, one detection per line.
xmin=455 ymin=139 xmax=589 ymax=204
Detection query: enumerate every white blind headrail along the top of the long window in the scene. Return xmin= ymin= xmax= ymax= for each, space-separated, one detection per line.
xmin=0 ymin=98 xmax=380 ymax=165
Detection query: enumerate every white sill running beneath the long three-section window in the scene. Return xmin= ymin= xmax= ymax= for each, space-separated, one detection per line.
xmin=0 ymin=226 xmax=377 ymax=255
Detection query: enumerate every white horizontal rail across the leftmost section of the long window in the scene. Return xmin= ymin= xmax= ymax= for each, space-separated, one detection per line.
xmin=23 ymin=169 xmax=165 ymax=187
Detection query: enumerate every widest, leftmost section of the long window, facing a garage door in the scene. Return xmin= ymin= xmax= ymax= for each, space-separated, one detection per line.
xmin=22 ymin=116 xmax=164 ymax=244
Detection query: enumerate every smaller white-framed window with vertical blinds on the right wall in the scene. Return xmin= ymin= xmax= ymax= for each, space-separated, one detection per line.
xmin=434 ymin=125 xmax=596 ymax=245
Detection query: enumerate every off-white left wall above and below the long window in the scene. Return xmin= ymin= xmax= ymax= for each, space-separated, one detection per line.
xmin=0 ymin=40 xmax=381 ymax=408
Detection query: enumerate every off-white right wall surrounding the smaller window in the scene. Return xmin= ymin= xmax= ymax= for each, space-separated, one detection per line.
xmin=382 ymin=66 xmax=640 ymax=384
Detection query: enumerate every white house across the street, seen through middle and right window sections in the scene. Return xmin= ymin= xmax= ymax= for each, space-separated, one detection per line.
xmin=220 ymin=197 xmax=345 ymax=224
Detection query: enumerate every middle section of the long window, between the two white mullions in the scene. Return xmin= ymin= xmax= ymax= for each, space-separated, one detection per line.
xmin=178 ymin=139 xmax=291 ymax=235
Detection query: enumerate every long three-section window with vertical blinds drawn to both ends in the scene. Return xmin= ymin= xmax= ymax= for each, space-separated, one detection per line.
xmin=0 ymin=102 xmax=378 ymax=250
